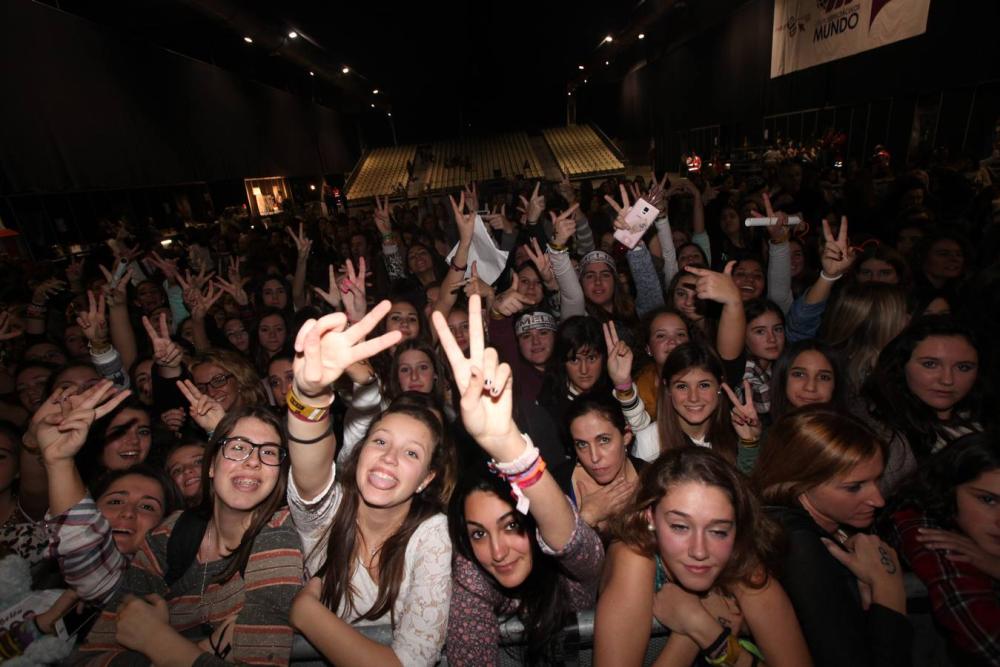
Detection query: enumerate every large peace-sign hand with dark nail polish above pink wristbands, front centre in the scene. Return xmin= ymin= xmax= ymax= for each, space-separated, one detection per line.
xmin=431 ymin=296 xmax=525 ymax=461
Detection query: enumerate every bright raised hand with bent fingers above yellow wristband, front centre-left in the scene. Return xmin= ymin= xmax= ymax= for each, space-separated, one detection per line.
xmin=292 ymin=301 xmax=400 ymax=407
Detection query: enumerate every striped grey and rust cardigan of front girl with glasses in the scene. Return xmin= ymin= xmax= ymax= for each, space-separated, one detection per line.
xmin=73 ymin=510 xmax=304 ymax=666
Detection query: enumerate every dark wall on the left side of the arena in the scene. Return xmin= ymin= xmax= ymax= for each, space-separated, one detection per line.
xmin=0 ymin=0 xmax=356 ymax=194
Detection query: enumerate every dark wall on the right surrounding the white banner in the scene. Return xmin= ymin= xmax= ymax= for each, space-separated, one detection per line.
xmin=577 ymin=0 xmax=1000 ymax=168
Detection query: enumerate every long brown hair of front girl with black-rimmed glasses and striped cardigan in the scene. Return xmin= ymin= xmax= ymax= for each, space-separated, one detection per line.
xmin=195 ymin=404 xmax=290 ymax=584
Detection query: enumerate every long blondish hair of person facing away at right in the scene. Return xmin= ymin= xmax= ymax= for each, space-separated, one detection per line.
xmin=820 ymin=283 xmax=909 ymax=393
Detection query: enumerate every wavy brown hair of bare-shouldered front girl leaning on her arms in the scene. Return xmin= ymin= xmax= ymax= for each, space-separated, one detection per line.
xmin=610 ymin=447 xmax=779 ymax=590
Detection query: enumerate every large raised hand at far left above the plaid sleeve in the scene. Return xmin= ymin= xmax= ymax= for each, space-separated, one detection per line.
xmin=30 ymin=380 xmax=131 ymax=466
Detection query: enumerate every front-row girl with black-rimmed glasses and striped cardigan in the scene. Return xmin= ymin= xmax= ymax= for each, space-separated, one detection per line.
xmin=76 ymin=407 xmax=303 ymax=665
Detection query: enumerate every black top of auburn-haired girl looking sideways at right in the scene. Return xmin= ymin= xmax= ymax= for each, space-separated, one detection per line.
xmin=767 ymin=507 xmax=913 ymax=667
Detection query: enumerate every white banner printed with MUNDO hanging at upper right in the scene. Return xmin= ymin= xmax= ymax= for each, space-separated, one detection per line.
xmin=771 ymin=0 xmax=931 ymax=79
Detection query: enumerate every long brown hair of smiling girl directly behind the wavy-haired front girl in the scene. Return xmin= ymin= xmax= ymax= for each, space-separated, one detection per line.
xmin=656 ymin=342 xmax=739 ymax=463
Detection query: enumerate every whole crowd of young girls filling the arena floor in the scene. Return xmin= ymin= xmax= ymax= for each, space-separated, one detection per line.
xmin=0 ymin=154 xmax=1000 ymax=667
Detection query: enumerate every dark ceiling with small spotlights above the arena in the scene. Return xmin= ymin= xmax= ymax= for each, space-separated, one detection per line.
xmin=37 ymin=0 xmax=720 ymax=144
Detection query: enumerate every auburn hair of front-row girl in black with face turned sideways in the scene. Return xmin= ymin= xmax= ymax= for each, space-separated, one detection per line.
xmin=751 ymin=405 xmax=886 ymax=507
